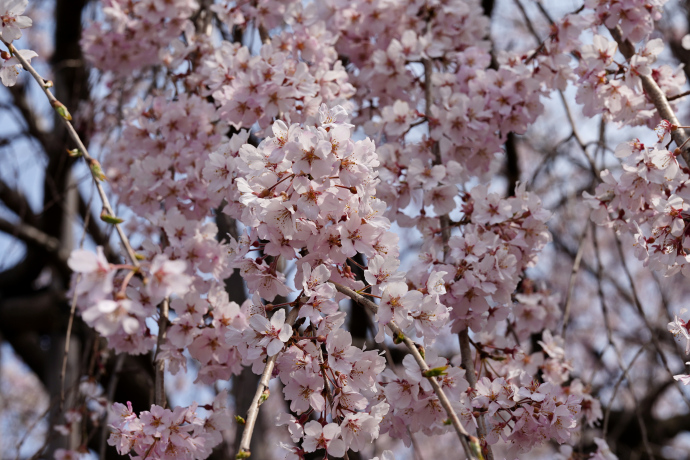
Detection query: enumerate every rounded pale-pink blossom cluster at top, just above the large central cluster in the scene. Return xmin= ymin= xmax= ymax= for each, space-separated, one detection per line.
xmin=199 ymin=2 xmax=354 ymax=135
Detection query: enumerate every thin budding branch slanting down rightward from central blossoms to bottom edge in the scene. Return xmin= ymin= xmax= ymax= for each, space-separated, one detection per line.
xmin=330 ymin=280 xmax=478 ymax=460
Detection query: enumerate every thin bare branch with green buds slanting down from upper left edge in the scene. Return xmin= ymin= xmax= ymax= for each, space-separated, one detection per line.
xmin=2 ymin=40 xmax=139 ymax=268
